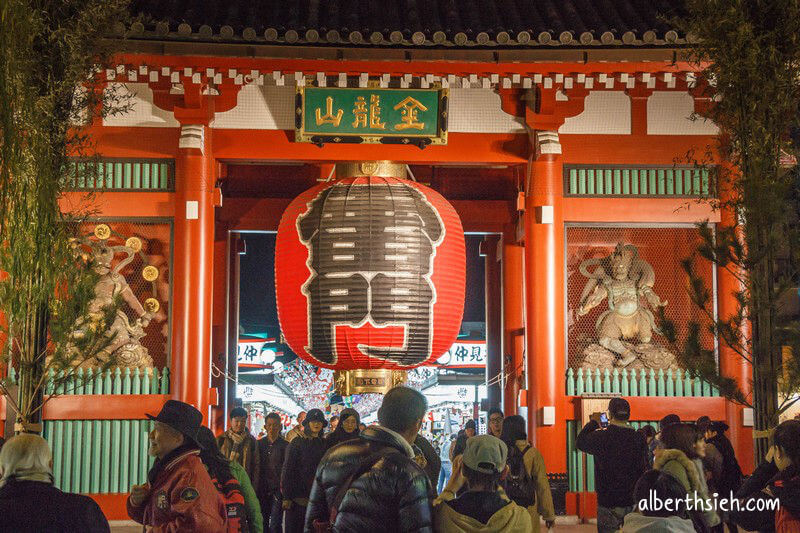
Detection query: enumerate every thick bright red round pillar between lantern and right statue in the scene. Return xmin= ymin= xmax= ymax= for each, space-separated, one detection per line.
xmin=525 ymin=132 xmax=567 ymax=472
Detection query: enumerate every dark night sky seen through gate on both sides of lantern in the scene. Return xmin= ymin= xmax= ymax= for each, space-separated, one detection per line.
xmin=239 ymin=233 xmax=485 ymax=335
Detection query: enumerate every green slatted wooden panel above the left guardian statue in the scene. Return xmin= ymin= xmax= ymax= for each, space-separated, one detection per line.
xmin=68 ymin=159 xmax=175 ymax=191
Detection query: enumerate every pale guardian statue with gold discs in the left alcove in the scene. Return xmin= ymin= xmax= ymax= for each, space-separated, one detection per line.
xmin=73 ymin=228 xmax=160 ymax=368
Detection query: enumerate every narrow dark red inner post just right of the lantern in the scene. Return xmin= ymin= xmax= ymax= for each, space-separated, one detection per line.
xmin=481 ymin=235 xmax=503 ymax=408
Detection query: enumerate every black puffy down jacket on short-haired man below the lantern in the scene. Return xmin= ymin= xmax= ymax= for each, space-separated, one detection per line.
xmin=305 ymin=426 xmax=435 ymax=533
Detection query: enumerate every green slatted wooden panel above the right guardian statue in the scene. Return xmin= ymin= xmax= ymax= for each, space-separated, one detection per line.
xmin=564 ymin=165 xmax=715 ymax=197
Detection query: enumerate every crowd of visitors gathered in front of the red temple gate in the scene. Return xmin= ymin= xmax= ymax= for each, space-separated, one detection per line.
xmin=0 ymin=386 xmax=800 ymax=533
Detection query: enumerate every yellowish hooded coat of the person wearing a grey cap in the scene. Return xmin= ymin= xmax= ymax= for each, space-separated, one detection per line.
xmin=433 ymin=491 xmax=533 ymax=533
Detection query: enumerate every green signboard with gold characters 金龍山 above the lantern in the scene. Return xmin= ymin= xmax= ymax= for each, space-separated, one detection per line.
xmin=295 ymin=87 xmax=447 ymax=148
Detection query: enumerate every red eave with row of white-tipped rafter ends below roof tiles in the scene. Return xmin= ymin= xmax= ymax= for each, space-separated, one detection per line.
xmin=105 ymin=55 xmax=700 ymax=92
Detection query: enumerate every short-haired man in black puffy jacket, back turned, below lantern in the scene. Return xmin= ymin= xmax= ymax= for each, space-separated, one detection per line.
xmin=305 ymin=386 xmax=435 ymax=533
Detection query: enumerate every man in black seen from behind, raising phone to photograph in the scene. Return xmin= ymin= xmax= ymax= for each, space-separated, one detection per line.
xmin=576 ymin=398 xmax=647 ymax=533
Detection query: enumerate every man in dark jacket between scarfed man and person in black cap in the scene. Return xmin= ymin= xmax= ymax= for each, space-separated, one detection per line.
xmin=257 ymin=413 xmax=289 ymax=533
